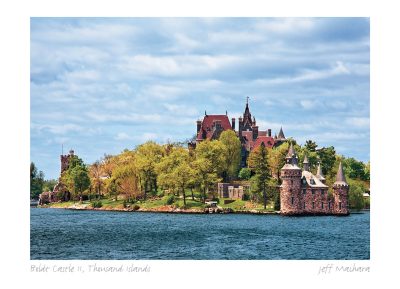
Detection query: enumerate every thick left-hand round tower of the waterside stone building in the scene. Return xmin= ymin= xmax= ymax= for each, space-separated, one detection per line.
xmin=280 ymin=144 xmax=302 ymax=215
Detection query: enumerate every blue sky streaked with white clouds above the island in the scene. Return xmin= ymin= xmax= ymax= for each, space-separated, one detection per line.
xmin=30 ymin=18 xmax=370 ymax=179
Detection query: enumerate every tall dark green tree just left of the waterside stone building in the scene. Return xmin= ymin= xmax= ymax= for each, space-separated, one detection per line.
xmin=249 ymin=143 xmax=271 ymax=209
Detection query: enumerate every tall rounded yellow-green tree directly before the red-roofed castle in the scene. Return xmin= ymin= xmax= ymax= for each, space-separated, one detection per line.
xmin=219 ymin=130 xmax=242 ymax=180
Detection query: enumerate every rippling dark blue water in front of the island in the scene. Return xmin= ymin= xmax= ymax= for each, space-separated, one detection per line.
xmin=31 ymin=208 xmax=370 ymax=260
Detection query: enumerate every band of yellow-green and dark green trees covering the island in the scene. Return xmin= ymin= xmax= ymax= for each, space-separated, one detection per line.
xmin=31 ymin=130 xmax=369 ymax=209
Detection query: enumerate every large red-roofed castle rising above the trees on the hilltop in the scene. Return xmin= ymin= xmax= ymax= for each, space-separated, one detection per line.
xmin=189 ymin=97 xmax=286 ymax=167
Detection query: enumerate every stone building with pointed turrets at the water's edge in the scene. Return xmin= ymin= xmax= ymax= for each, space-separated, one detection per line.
xmin=280 ymin=145 xmax=349 ymax=215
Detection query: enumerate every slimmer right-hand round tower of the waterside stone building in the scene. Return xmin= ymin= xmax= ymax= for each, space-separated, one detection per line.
xmin=333 ymin=162 xmax=350 ymax=215
